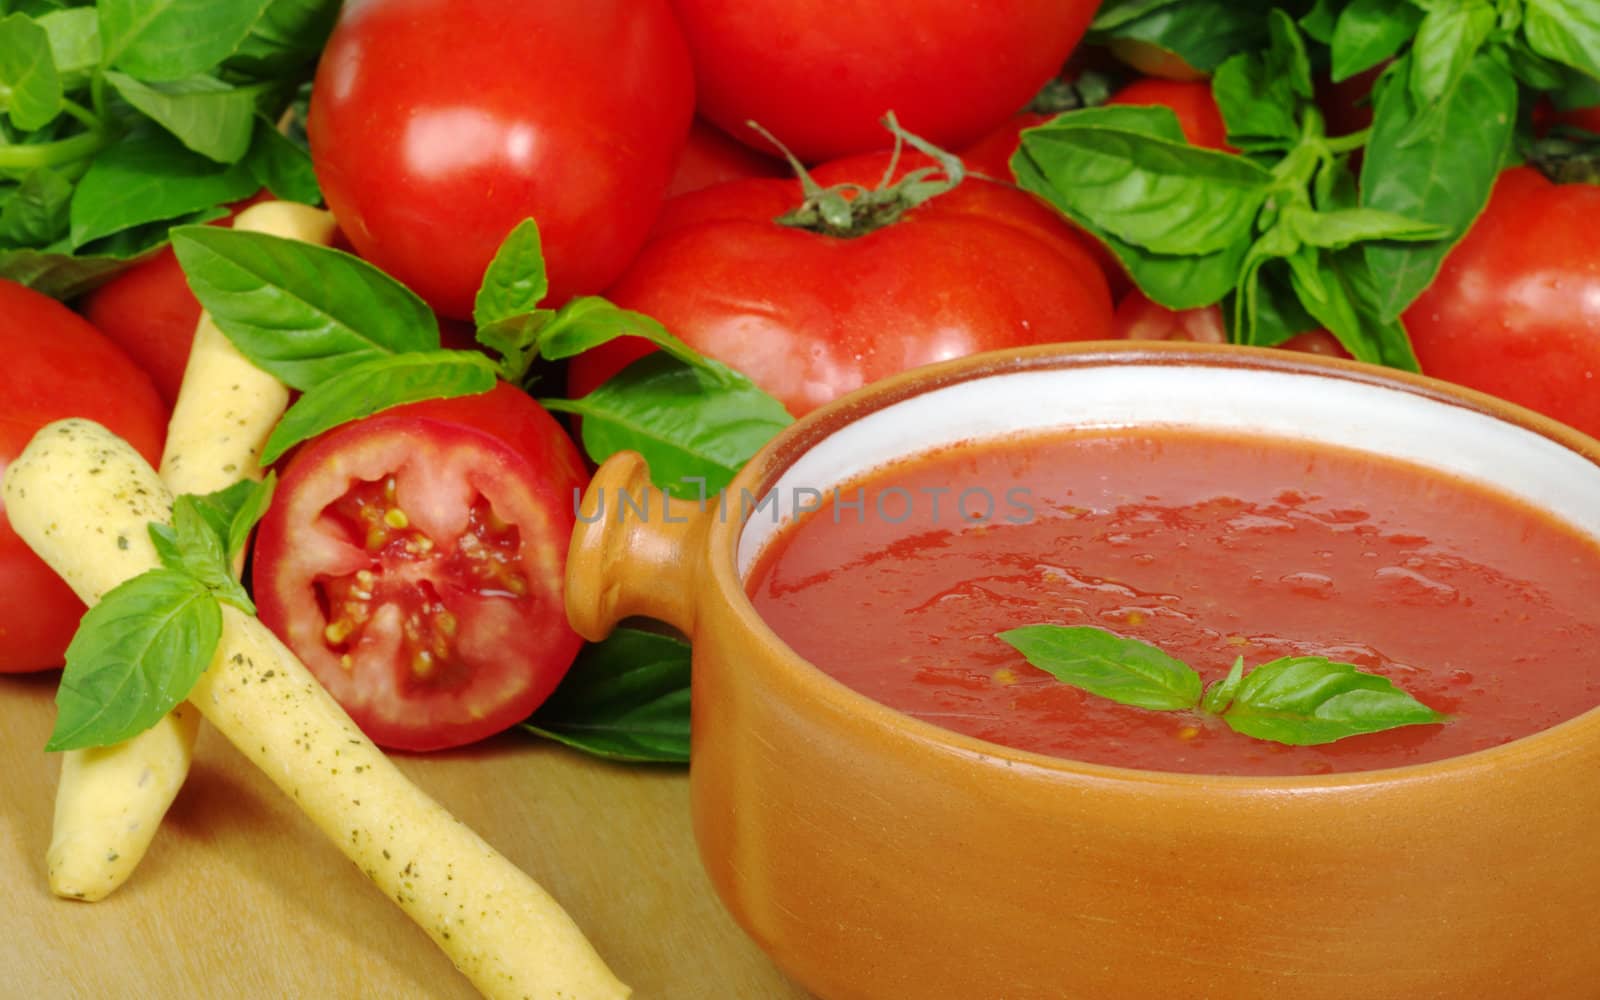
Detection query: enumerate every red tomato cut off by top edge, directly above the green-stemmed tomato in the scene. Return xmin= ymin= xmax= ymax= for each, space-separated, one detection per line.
xmin=672 ymin=0 xmax=1099 ymax=163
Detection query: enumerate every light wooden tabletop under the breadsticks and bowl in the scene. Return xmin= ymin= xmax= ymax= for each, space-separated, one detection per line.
xmin=0 ymin=675 xmax=805 ymax=1000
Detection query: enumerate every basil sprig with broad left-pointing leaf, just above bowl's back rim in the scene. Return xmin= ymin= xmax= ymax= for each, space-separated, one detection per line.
xmin=1011 ymin=8 xmax=1445 ymax=370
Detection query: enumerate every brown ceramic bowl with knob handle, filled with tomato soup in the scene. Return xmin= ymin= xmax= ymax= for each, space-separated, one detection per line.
xmin=568 ymin=344 xmax=1600 ymax=998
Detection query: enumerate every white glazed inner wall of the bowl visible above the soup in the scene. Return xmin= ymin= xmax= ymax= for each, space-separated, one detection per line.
xmin=736 ymin=355 xmax=1600 ymax=566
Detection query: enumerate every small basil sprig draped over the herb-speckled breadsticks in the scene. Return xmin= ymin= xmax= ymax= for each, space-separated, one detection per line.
xmin=45 ymin=475 xmax=274 ymax=750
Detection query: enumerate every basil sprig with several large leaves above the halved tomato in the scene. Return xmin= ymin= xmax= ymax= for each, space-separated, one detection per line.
xmin=173 ymin=219 xmax=792 ymax=496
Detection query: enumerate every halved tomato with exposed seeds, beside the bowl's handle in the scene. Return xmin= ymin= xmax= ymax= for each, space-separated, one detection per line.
xmin=253 ymin=382 xmax=587 ymax=750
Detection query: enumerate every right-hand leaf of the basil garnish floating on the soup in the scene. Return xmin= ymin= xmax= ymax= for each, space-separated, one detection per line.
xmin=1222 ymin=656 xmax=1446 ymax=746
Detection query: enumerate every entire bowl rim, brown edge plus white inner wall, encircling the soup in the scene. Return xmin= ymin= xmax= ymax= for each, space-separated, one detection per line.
xmin=732 ymin=342 xmax=1600 ymax=790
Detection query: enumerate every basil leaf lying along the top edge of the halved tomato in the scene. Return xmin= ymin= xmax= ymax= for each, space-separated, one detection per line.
xmin=261 ymin=350 xmax=496 ymax=462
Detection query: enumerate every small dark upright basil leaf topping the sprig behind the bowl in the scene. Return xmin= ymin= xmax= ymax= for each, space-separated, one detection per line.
xmin=1211 ymin=10 xmax=1312 ymax=150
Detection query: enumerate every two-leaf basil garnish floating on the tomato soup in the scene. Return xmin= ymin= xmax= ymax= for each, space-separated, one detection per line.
xmin=998 ymin=626 xmax=1446 ymax=746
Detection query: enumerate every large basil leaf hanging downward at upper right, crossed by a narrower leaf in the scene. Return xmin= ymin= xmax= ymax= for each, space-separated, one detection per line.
xmin=1362 ymin=53 xmax=1517 ymax=323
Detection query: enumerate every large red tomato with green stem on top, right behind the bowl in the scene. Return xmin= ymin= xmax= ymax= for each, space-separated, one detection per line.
xmin=570 ymin=154 xmax=1112 ymax=416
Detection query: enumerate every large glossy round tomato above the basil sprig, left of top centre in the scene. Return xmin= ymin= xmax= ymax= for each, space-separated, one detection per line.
xmin=307 ymin=0 xmax=694 ymax=318
